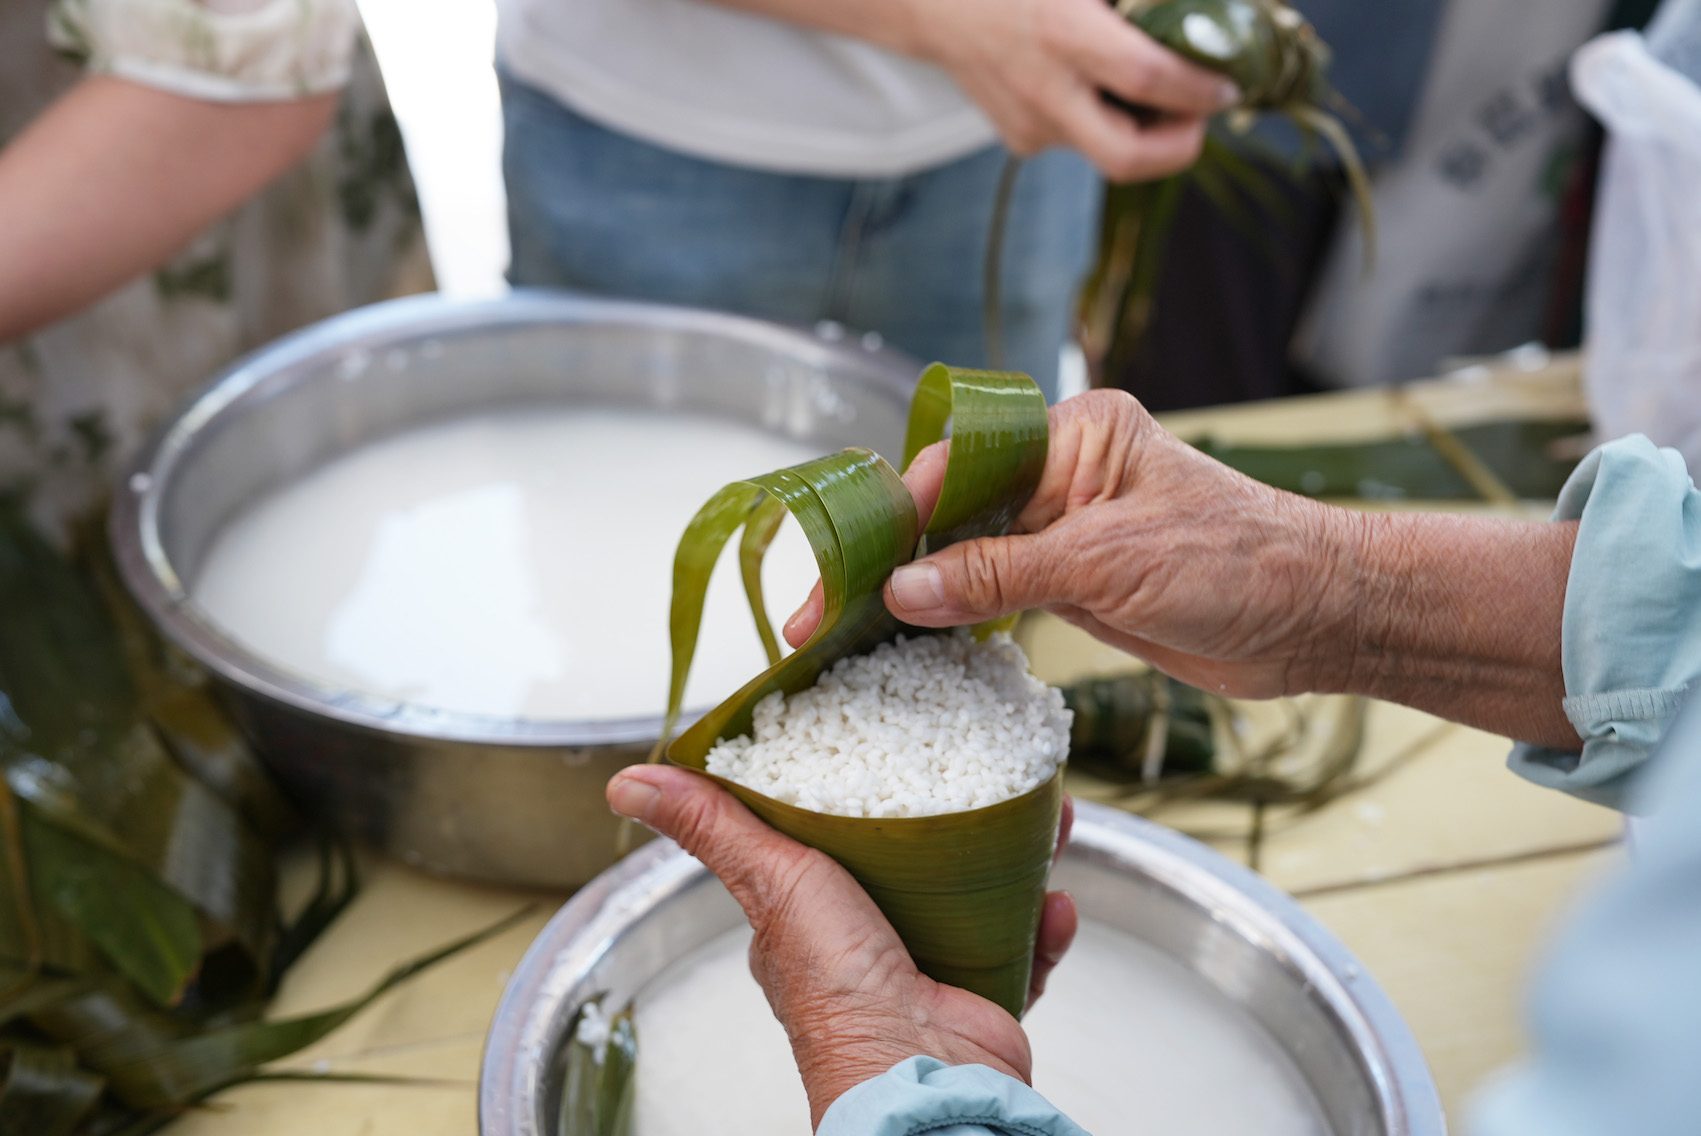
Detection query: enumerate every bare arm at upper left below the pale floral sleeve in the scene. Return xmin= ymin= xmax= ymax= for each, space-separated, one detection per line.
xmin=0 ymin=77 xmax=337 ymax=342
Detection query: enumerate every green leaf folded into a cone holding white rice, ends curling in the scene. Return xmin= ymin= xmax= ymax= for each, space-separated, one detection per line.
xmin=667 ymin=364 xmax=1061 ymax=1014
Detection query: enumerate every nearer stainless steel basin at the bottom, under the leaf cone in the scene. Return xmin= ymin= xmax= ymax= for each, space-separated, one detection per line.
xmin=478 ymin=803 xmax=1446 ymax=1136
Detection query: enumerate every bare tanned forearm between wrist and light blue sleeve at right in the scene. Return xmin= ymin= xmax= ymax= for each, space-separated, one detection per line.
xmin=1317 ymin=514 xmax=1582 ymax=750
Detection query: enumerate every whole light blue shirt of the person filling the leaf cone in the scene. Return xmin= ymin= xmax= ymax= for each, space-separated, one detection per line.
xmin=816 ymin=437 xmax=1701 ymax=1136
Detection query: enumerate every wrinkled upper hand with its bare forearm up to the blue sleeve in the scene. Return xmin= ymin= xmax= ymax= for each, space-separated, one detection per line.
xmin=786 ymin=391 xmax=1579 ymax=748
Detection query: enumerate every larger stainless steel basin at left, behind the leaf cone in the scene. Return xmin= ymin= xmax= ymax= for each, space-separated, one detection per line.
xmin=111 ymin=291 xmax=919 ymax=888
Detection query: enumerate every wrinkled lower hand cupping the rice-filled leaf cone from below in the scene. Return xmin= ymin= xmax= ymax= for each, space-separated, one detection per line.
xmin=609 ymin=765 xmax=1077 ymax=1124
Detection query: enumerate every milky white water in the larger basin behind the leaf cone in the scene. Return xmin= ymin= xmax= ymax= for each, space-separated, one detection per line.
xmin=192 ymin=408 xmax=822 ymax=719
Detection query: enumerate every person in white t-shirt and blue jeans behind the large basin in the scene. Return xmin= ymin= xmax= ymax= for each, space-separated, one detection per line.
xmin=497 ymin=0 xmax=1235 ymax=388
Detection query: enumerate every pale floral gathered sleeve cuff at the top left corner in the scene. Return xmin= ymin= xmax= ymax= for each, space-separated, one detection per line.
xmin=48 ymin=0 xmax=361 ymax=102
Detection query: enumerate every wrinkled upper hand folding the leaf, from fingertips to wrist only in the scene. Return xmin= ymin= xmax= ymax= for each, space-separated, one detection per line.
xmin=786 ymin=391 xmax=1361 ymax=697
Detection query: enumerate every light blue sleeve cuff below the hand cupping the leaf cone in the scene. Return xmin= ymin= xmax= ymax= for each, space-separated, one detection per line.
xmin=815 ymin=1058 xmax=1087 ymax=1136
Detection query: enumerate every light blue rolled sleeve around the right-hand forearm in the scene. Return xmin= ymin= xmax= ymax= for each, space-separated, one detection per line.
xmin=1509 ymin=435 xmax=1701 ymax=808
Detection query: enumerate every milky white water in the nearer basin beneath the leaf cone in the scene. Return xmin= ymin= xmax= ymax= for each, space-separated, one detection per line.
xmin=634 ymin=920 xmax=1328 ymax=1136
